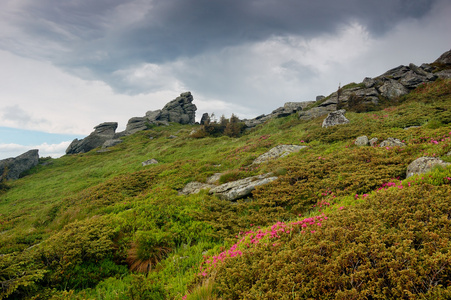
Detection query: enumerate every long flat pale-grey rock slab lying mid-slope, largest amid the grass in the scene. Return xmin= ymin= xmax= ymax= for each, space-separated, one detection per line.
xmin=209 ymin=173 xmax=277 ymax=201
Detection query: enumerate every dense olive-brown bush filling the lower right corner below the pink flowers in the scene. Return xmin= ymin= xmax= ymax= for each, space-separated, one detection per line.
xmin=215 ymin=184 xmax=451 ymax=299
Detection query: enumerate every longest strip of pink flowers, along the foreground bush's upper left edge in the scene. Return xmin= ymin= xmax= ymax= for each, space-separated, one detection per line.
xmin=200 ymin=214 xmax=327 ymax=277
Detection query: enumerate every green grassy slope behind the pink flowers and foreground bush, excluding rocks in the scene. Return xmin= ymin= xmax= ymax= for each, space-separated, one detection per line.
xmin=0 ymin=80 xmax=451 ymax=299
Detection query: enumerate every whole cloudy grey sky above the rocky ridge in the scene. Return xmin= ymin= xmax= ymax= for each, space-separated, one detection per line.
xmin=0 ymin=0 xmax=451 ymax=159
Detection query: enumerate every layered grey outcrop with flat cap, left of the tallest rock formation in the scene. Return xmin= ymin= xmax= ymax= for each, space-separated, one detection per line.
xmin=66 ymin=122 xmax=117 ymax=154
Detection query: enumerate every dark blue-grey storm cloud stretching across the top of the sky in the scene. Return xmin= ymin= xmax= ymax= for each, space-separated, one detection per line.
xmin=0 ymin=0 xmax=442 ymax=93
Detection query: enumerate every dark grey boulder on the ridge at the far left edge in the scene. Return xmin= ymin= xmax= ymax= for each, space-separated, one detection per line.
xmin=0 ymin=149 xmax=39 ymax=180
